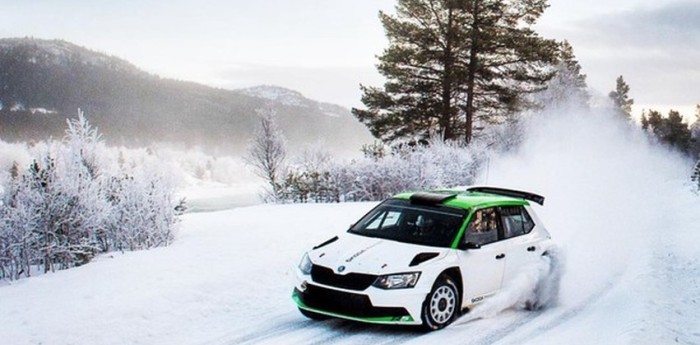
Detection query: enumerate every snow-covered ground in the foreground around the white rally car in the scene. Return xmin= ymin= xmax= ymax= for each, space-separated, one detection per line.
xmin=0 ymin=194 xmax=700 ymax=345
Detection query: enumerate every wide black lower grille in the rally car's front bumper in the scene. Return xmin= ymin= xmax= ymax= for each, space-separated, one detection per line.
xmin=297 ymin=284 xmax=408 ymax=317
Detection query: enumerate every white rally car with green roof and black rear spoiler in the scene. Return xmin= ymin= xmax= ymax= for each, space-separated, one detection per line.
xmin=292 ymin=187 xmax=555 ymax=330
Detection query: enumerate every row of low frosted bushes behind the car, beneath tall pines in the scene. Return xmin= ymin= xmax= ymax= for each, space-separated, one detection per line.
xmin=281 ymin=138 xmax=487 ymax=202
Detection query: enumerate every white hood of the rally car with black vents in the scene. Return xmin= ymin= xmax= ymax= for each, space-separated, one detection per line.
xmin=309 ymin=233 xmax=449 ymax=275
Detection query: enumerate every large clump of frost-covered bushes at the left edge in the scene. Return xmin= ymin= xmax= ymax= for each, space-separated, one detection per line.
xmin=0 ymin=113 xmax=177 ymax=279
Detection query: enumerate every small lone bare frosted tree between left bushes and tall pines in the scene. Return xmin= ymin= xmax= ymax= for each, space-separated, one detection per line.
xmin=245 ymin=109 xmax=287 ymax=200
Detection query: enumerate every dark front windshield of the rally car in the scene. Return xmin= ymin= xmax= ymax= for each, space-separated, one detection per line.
xmin=348 ymin=199 xmax=467 ymax=247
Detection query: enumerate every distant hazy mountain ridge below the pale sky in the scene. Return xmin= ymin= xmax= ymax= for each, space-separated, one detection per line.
xmin=0 ymin=38 xmax=372 ymax=153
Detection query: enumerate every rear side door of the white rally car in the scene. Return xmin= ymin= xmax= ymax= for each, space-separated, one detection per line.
xmin=498 ymin=206 xmax=544 ymax=285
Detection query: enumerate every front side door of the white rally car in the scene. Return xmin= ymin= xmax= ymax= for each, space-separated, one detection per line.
xmin=458 ymin=208 xmax=506 ymax=305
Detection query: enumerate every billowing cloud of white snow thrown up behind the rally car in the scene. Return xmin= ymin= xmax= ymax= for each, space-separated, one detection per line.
xmin=484 ymin=105 xmax=691 ymax=312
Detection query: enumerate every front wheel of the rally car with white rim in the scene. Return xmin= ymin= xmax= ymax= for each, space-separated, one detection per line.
xmin=422 ymin=276 xmax=460 ymax=331
